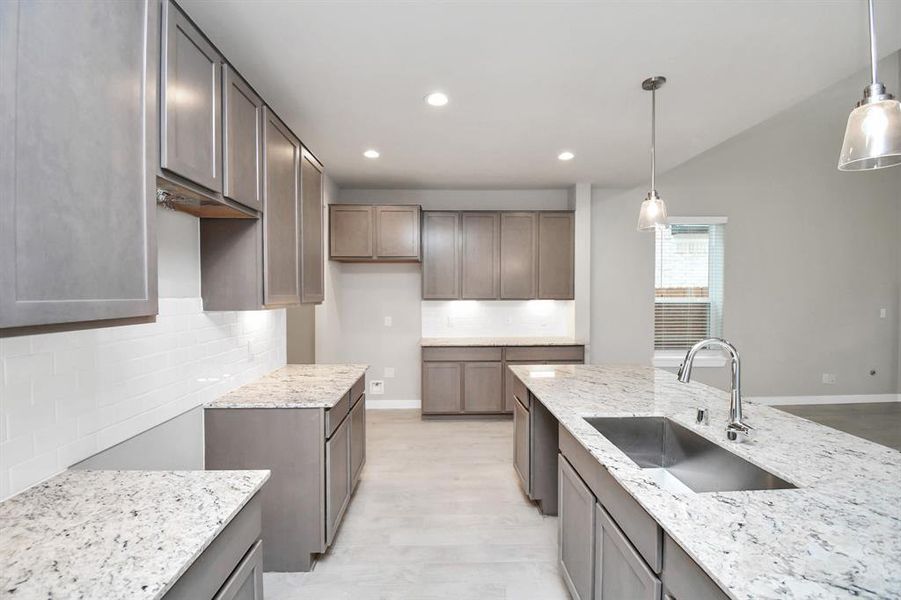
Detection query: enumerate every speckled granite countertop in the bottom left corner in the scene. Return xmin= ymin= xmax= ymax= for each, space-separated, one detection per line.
xmin=0 ymin=471 xmax=269 ymax=600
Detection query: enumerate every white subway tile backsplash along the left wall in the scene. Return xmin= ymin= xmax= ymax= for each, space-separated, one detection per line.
xmin=0 ymin=298 xmax=285 ymax=499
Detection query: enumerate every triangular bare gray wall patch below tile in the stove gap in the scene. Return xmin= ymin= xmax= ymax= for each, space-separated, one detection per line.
xmin=72 ymin=406 xmax=203 ymax=471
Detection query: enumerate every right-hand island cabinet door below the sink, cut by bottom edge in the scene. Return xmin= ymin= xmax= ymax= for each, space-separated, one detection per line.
xmin=594 ymin=504 xmax=661 ymax=600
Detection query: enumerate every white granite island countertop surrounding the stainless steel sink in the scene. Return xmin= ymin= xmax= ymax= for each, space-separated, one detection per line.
xmin=511 ymin=365 xmax=901 ymax=600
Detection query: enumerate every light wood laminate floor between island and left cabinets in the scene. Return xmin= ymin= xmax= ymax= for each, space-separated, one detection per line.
xmin=263 ymin=410 xmax=569 ymax=600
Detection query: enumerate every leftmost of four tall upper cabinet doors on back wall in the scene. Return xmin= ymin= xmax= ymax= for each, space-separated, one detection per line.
xmin=422 ymin=211 xmax=460 ymax=300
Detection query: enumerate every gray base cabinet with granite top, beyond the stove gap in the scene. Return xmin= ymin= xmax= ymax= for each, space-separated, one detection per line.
xmin=204 ymin=364 xmax=368 ymax=572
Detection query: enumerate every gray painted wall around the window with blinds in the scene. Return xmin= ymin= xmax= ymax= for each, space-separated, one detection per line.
xmin=591 ymin=54 xmax=901 ymax=396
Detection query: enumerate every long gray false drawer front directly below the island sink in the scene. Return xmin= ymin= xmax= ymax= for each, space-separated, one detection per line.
xmin=559 ymin=425 xmax=663 ymax=573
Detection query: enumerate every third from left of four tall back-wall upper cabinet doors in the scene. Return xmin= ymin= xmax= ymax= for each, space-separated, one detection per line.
xmin=500 ymin=212 xmax=538 ymax=300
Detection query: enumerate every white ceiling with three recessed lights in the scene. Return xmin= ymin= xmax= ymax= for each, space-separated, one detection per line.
xmin=181 ymin=0 xmax=901 ymax=188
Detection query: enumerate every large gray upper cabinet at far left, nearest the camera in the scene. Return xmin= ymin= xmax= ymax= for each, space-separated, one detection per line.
xmin=0 ymin=0 xmax=159 ymax=328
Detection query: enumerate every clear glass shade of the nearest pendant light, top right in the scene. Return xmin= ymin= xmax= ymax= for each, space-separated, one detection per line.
xmin=838 ymin=98 xmax=901 ymax=171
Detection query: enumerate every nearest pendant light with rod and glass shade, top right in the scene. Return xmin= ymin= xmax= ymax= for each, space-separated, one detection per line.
xmin=838 ymin=0 xmax=901 ymax=171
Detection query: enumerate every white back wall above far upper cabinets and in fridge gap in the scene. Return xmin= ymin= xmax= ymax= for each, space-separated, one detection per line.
xmin=316 ymin=188 xmax=571 ymax=406
